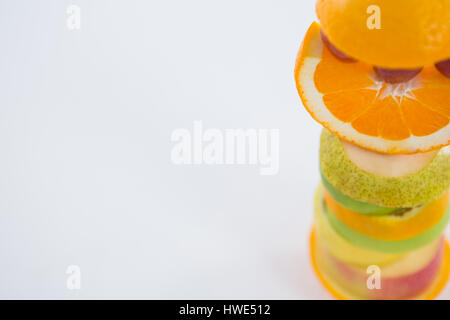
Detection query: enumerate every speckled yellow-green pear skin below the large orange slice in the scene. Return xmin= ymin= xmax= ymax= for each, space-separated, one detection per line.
xmin=319 ymin=129 xmax=450 ymax=208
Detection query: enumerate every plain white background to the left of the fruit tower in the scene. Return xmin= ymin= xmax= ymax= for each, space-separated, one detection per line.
xmin=0 ymin=0 xmax=450 ymax=299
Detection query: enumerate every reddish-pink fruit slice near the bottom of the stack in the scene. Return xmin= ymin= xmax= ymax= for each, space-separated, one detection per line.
xmin=324 ymin=239 xmax=445 ymax=300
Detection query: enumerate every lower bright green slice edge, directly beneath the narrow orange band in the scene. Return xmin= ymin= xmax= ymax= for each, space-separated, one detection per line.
xmin=324 ymin=204 xmax=450 ymax=253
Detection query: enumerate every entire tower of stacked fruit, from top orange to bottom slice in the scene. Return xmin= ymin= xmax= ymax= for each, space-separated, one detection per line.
xmin=295 ymin=0 xmax=450 ymax=299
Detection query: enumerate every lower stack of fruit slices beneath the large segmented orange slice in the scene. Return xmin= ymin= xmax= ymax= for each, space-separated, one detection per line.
xmin=312 ymin=129 xmax=450 ymax=299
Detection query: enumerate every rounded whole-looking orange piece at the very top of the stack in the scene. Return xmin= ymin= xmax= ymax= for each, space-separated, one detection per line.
xmin=316 ymin=0 xmax=450 ymax=69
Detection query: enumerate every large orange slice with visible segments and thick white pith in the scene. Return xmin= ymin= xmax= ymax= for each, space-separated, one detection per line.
xmin=295 ymin=22 xmax=450 ymax=154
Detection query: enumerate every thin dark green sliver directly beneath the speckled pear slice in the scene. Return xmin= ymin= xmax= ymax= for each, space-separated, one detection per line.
xmin=320 ymin=172 xmax=399 ymax=216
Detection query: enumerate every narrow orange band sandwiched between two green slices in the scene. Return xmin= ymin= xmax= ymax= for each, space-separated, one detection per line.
xmin=324 ymin=189 xmax=448 ymax=241
